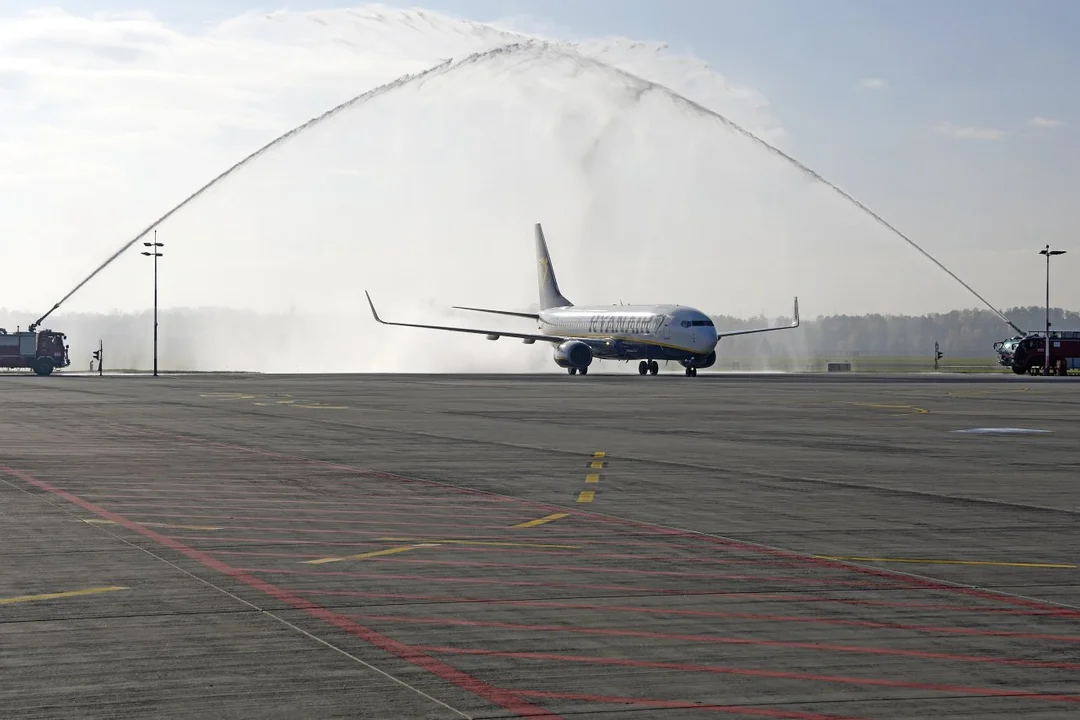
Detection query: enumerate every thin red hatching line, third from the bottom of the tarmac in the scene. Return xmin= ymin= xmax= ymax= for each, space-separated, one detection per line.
xmin=347 ymin=613 xmax=1080 ymax=670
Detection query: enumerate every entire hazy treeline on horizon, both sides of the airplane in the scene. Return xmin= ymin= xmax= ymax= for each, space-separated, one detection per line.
xmin=0 ymin=307 xmax=1080 ymax=369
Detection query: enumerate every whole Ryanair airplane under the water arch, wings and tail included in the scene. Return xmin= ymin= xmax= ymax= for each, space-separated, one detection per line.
xmin=364 ymin=222 xmax=799 ymax=377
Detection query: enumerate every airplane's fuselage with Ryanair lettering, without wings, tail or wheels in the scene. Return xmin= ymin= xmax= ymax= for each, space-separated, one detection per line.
xmin=539 ymin=305 xmax=717 ymax=355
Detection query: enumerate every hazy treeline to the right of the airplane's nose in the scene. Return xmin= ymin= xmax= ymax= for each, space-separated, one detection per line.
xmin=713 ymin=307 xmax=1080 ymax=357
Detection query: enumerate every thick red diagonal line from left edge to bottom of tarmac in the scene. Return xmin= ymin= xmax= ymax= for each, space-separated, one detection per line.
xmin=0 ymin=464 xmax=562 ymax=720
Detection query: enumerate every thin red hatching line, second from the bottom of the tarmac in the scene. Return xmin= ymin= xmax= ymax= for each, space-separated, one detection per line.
xmin=417 ymin=646 xmax=1080 ymax=703
